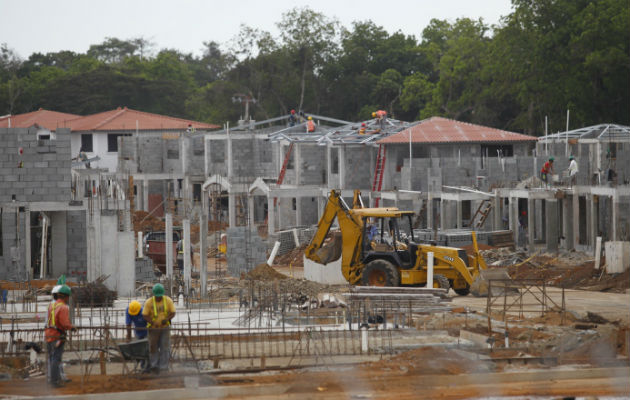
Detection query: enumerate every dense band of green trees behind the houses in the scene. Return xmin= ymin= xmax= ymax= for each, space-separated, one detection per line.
xmin=0 ymin=0 xmax=630 ymax=135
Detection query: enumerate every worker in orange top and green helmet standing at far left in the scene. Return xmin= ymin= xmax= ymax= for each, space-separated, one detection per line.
xmin=44 ymin=284 xmax=75 ymax=387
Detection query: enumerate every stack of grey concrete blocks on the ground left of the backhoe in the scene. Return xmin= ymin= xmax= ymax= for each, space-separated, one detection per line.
xmin=226 ymin=226 xmax=267 ymax=277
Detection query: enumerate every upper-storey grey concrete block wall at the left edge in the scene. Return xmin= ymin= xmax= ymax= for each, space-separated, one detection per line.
xmin=0 ymin=127 xmax=72 ymax=202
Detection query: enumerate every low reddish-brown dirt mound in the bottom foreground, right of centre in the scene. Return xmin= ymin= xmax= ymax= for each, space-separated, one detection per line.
xmin=364 ymin=347 xmax=488 ymax=375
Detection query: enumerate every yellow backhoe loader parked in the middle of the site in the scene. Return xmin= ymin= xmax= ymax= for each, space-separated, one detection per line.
xmin=304 ymin=190 xmax=486 ymax=295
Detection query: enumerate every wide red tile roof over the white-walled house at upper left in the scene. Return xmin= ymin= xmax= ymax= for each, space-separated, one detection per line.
xmin=62 ymin=107 xmax=219 ymax=131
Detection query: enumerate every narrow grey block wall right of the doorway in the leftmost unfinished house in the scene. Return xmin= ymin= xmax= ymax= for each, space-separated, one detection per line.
xmin=66 ymin=211 xmax=87 ymax=279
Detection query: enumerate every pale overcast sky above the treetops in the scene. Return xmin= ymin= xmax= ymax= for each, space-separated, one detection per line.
xmin=0 ymin=0 xmax=511 ymax=58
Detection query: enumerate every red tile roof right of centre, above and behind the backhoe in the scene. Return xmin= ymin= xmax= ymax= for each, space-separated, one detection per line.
xmin=377 ymin=117 xmax=536 ymax=144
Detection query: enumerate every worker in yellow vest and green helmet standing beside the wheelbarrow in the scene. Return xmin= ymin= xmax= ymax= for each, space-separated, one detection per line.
xmin=142 ymin=283 xmax=175 ymax=373
